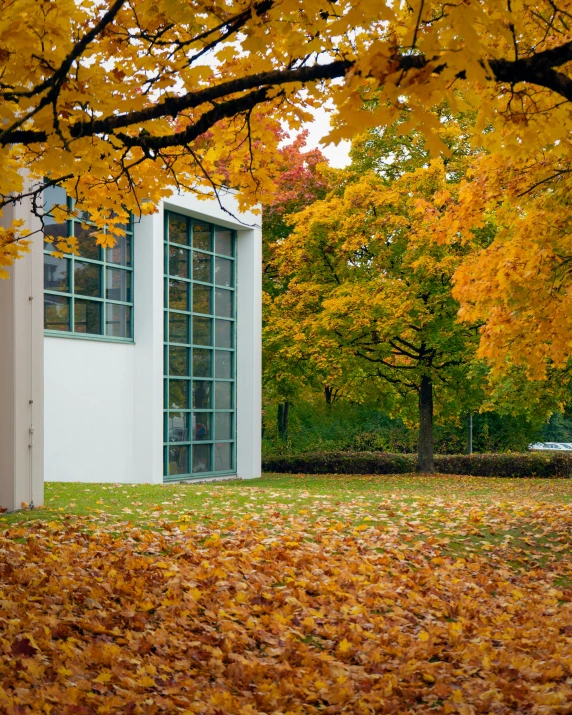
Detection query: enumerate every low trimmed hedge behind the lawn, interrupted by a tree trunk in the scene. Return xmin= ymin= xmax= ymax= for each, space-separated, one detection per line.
xmin=262 ymin=452 xmax=572 ymax=477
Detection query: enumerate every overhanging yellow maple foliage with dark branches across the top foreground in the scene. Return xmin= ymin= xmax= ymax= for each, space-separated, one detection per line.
xmin=0 ymin=0 xmax=572 ymax=290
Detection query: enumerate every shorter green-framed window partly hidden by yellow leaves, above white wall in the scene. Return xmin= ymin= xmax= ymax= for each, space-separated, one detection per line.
xmin=44 ymin=187 xmax=133 ymax=341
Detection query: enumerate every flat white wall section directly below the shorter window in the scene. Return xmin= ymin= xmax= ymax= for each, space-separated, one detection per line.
xmin=44 ymin=337 xmax=139 ymax=482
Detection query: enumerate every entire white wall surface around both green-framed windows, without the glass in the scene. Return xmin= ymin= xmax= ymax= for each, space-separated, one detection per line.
xmin=45 ymin=189 xmax=262 ymax=483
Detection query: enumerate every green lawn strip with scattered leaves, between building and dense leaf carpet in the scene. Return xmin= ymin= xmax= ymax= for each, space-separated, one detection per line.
xmin=4 ymin=474 xmax=572 ymax=563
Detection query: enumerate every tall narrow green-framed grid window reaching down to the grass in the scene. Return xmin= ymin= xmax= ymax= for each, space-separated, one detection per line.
xmin=164 ymin=212 xmax=236 ymax=480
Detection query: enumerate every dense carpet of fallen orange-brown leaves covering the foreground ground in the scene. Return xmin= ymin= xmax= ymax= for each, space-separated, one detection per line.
xmin=0 ymin=498 xmax=572 ymax=715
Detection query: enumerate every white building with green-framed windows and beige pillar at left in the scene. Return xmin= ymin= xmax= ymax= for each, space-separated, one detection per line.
xmin=0 ymin=185 xmax=261 ymax=509
